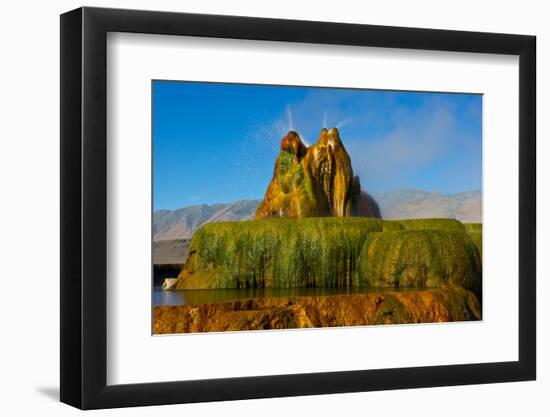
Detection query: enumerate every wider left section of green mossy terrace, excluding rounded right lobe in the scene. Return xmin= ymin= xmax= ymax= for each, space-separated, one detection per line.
xmin=179 ymin=217 xmax=385 ymax=288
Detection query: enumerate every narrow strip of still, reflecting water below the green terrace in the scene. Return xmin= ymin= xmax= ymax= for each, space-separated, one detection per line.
xmin=153 ymin=287 xmax=414 ymax=306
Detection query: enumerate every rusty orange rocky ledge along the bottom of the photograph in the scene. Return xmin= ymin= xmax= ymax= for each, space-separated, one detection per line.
xmin=153 ymin=287 xmax=481 ymax=334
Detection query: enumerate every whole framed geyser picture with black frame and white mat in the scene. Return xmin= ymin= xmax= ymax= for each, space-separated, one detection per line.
xmin=61 ymin=7 xmax=536 ymax=409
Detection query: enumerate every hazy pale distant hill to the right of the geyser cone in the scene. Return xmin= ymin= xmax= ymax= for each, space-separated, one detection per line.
xmin=373 ymin=189 xmax=482 ymax=223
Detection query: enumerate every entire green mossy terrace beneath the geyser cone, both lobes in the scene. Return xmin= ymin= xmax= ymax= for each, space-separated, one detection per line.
xmin=178 ymin=217 xmax=481 ymax=293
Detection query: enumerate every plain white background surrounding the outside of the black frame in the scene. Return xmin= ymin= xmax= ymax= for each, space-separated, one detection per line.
xmin=0 ymin=0 xmax=550 ymax=417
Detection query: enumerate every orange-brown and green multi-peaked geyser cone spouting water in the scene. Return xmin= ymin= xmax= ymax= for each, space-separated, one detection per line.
xmin=256 ymin=128 xmax=381 ymax=219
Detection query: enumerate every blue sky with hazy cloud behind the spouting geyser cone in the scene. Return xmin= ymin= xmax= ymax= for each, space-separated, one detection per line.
xmin=153 ymin=81 xmax=482 ymax=210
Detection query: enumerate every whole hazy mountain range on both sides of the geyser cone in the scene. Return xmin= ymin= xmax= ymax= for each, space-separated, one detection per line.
xmin=153 ymin=189 xmax=481 ymax=241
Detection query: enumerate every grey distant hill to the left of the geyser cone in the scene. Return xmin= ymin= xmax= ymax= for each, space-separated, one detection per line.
xmin=153 ymin=200 xmax=260 ymax=241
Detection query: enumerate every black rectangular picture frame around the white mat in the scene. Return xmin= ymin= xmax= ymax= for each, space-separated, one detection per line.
xmin=60 ymin=7 xmax=536 ymax=409
